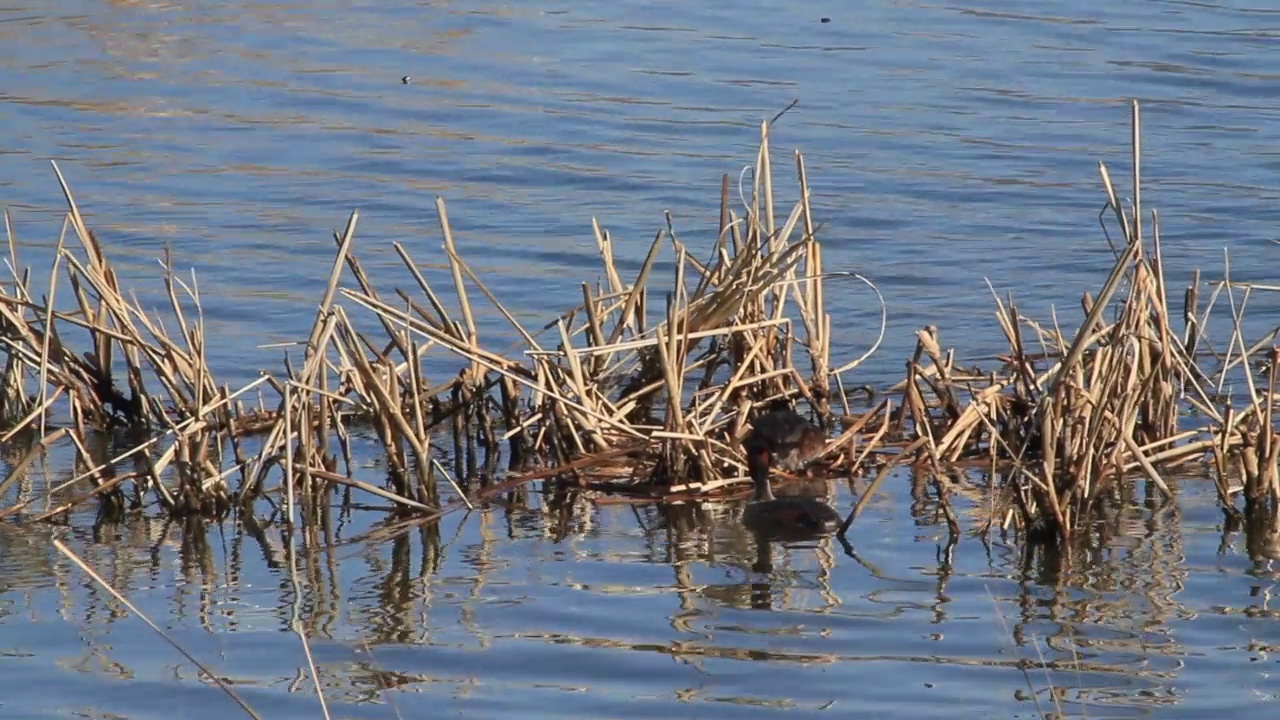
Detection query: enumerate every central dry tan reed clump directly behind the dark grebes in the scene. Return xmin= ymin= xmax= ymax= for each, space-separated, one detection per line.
xmin=325 ymin=119 xmax=883 ymax=496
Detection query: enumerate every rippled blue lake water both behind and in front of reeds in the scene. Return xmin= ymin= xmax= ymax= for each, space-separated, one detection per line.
xmin=0 ymin=0 xmax=1280 ymax=719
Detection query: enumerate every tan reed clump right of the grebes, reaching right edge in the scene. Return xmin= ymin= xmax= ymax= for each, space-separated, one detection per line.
xmin=899 ymin=102 xmax=1280 ymax=539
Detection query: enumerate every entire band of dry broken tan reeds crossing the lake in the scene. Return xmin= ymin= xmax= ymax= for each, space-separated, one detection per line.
xmin=0 ymin=104 xmax=1280 ymax=539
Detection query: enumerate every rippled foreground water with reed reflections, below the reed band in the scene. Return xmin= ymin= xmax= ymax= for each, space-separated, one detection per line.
xmin=0 ymin=461 xmax=1277 ymax=717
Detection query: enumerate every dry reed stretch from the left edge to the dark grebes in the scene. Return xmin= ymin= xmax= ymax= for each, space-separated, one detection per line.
xmin=0 ymin=119 xmax=884 ymax=523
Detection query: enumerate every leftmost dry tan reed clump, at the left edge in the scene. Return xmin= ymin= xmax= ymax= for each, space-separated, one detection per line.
xmin=0 ymin=165 xmax=275 ymax=516
